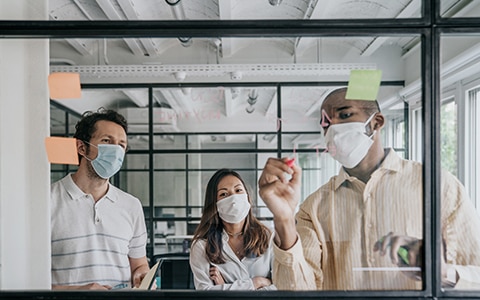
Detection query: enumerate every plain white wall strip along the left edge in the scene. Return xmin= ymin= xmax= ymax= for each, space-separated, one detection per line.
xmin=0 ymin=0 xmax=50 ymax=290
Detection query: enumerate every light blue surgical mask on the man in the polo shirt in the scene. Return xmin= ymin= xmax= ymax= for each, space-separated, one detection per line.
xmin=83 ymin=142 xmax=125 ymax=179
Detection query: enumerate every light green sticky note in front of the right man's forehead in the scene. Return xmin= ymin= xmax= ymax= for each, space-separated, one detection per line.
xmin=345 ymin=70 xmax=382 ymax=101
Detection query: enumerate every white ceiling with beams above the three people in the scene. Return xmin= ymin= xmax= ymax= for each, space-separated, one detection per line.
xmin=49 ymin=0 xmax=478 ymax=138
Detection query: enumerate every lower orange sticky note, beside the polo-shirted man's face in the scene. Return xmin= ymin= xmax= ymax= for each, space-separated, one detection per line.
xmin=45 ymin=136 xmax=78 ymax=165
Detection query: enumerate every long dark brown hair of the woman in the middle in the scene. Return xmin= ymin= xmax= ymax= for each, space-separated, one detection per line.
xmin=193 ymin=169 xmax=271 ymax=264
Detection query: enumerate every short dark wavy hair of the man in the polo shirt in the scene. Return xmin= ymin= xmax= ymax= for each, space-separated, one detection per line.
xmin=73 ymin=107 xmax=128 ymax=160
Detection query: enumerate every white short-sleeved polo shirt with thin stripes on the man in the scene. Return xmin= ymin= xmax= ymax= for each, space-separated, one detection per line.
xmin=51 ymin=174 xmax=147 ymax=287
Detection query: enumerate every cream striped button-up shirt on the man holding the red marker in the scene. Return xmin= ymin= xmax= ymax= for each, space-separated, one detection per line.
xmin=273 ymin=149 xmax=480 ymax=290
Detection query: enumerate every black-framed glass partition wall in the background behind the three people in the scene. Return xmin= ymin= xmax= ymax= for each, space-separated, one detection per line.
xmin=51 ymin=81 xmax=407 ymax=257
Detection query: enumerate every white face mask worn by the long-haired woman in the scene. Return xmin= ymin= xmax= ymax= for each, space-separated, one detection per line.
xmin=217 ymin=194 xmax=250 ymax=224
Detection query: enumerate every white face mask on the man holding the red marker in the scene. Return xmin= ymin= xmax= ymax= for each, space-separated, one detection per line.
xmin=325 ymin=114 xmax=376 ymax=169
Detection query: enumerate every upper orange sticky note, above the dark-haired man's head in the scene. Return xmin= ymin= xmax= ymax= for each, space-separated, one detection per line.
xmin=48 ymin=73 xmax=82 ymax=99
